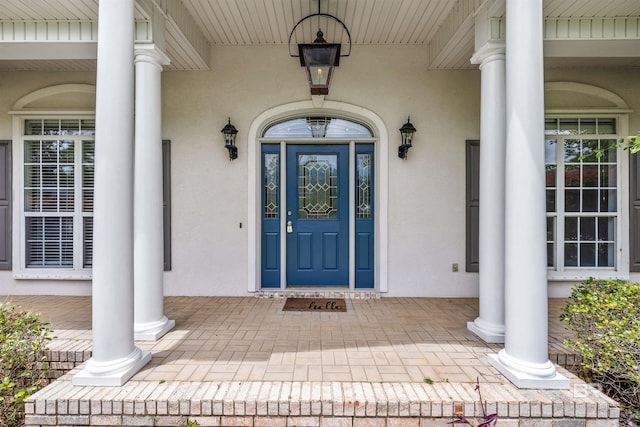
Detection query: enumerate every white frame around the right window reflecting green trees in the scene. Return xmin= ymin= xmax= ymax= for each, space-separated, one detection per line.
xmin=545 ymin=112 xmax=629 ymax=281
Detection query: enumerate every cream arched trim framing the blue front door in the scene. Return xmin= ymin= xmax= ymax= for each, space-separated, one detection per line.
xmin=247 ymin=100 xmax=389 ymax=292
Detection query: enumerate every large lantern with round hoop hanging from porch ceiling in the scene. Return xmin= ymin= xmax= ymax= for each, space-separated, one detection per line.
xmin=289 ymin=0 xmax=351 ymax=95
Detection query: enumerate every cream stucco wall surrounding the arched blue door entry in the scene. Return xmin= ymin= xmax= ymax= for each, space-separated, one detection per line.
xmin=0 ymin=46 xmax=640 ymax=296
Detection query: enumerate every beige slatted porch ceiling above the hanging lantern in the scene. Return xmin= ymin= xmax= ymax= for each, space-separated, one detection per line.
xmin=0 ymin=0 xmax=640 ymax=70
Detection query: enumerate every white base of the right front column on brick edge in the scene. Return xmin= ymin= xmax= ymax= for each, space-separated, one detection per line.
xmin=489 ymin=349 xmax=570 ymax=390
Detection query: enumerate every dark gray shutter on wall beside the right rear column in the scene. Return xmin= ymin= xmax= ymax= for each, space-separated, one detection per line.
xmin=466 ymin=140 xmax=480 ymax=272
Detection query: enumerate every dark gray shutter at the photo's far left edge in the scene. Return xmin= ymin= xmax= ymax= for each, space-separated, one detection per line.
xmin=0 ymin=141 xmax=11 ymax=270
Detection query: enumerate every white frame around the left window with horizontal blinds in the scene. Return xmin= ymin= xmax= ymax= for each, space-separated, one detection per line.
xmin=13 ymin=111 xmax=95 ymax=280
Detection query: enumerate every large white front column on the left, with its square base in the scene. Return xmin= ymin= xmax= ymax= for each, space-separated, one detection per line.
xmin=72 ymin=0 xmax=151 ymax=386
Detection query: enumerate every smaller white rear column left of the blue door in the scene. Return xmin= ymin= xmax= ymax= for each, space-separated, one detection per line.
xmin=134 ymin=44 xmax=175 ymax=341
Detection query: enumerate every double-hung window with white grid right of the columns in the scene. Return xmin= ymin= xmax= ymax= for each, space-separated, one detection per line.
xmin=545 ymin=117 xmax=622 ymax=275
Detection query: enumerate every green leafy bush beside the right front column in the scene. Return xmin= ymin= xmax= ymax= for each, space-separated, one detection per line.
xmin=561 ymin=279 xmax=640 ymax=412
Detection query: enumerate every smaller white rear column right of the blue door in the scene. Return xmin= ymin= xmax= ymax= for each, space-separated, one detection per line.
xmin=467 ymin=42 xmax=506 ymax=343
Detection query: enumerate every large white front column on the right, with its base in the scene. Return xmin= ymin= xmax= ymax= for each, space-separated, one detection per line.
xmin=489 ymin=0 xmax=569 ymax=389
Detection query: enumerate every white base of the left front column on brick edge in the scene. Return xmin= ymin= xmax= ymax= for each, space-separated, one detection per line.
xmin=71 ymin=347 xmax=151 ymax=387
